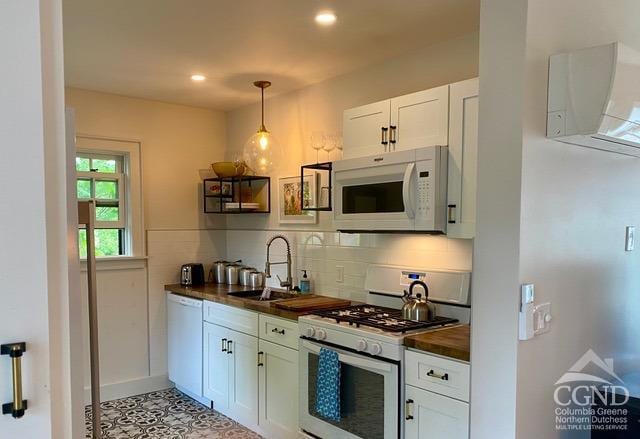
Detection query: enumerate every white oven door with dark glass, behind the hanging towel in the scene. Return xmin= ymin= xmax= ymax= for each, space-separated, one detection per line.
xmin=300 ymin=339 xmax=400 ymax=439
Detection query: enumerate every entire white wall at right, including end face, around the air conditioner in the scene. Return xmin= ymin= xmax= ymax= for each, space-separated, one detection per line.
xmin=471 ymin=0 xmax=640 ymax=439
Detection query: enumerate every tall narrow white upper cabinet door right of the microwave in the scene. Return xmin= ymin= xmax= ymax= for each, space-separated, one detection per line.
xmin=447 ymin=78 xmax=478 ymax=238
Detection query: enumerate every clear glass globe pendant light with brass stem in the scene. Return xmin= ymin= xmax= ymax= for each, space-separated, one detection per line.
xmin=242 ymin=81 xmax=281 ymax=175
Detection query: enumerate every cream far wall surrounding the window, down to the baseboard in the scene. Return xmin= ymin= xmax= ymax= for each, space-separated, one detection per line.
xmin=66 ymin=88 xmax=226 ymax=399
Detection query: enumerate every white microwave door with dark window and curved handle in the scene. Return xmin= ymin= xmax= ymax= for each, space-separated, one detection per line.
xmin=334 ymin=151 xmax=417 ymax=231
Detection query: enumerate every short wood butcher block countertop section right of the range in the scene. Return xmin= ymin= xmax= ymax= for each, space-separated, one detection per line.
xmin=404 ymin=325 xmax=471 ymax=361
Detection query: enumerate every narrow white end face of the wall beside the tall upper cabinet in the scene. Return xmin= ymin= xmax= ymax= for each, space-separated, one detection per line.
xmin=471 ymin=0 xmax=528 ymax=439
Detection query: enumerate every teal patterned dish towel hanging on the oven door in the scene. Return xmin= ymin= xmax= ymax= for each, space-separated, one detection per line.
xmin=316 ymin=348 xmax=340 ymax=422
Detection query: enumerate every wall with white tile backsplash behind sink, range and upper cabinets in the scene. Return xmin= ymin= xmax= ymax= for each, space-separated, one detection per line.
xmin=226 ymin=33 xmax=478 ymax=286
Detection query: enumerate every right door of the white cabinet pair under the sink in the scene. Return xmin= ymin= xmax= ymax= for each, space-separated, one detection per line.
xmin=229 ymin=330 xmax=258 ymax=426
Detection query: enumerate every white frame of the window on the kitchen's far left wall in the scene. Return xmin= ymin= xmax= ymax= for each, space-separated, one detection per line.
xmin=76 ymin=134 xmax=144 ymax=259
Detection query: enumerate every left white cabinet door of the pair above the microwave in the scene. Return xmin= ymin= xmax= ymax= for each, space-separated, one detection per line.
xmin=344 ymin=100 xmax=390 ymax=159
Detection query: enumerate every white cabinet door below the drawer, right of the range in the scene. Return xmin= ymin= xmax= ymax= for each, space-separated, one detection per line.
xmin=405 ymin=386 xmax=469 ymax=439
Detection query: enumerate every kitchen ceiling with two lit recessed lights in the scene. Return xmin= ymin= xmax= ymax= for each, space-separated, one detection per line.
xmin=63 ymin=0 xmax=479 ymax=110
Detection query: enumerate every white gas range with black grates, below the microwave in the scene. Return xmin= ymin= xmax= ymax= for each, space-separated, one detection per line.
xmin=298 ymin=266 xmax=470 ymax=439
